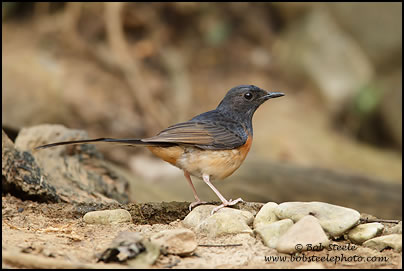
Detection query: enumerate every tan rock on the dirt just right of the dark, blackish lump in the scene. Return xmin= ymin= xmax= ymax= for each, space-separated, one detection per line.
xmin=150 ymin=228 xmax=198 ymax=256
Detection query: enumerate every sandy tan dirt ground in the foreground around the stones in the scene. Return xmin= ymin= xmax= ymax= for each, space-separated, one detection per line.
xmin=2 ymin=195 xmax=402 ymax=268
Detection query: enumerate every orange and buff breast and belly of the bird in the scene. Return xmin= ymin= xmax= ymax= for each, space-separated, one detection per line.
xmin=148 ymin=136 xmax=252 ymax=180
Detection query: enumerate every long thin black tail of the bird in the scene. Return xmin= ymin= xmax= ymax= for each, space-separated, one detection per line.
xmin=35 ymin=138 xmax=176 ymax=150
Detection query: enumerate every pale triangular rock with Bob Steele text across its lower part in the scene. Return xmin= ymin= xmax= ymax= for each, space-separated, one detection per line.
xmin=276 ymin=215 xmax=330 ymax=253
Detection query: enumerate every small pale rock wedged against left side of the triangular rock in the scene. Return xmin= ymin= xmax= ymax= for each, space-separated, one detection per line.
xmin=255 ymin=219 xmax=293 ymax=248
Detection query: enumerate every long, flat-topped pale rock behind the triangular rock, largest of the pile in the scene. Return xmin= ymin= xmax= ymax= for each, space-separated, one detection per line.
xmin=276 ymin=202 xmax=360 ymax=237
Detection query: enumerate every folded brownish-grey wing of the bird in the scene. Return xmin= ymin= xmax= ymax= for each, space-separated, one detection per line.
xmin=142 ymin=121 xmax=246 ymax=149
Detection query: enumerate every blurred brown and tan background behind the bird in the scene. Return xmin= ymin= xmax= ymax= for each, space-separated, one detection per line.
xmin=2 ymin=2 xmax=402 ymax=218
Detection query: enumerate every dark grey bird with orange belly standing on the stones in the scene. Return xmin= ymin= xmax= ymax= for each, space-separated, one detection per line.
xmin=35 ymin=85 xmax=285 ymax=214
